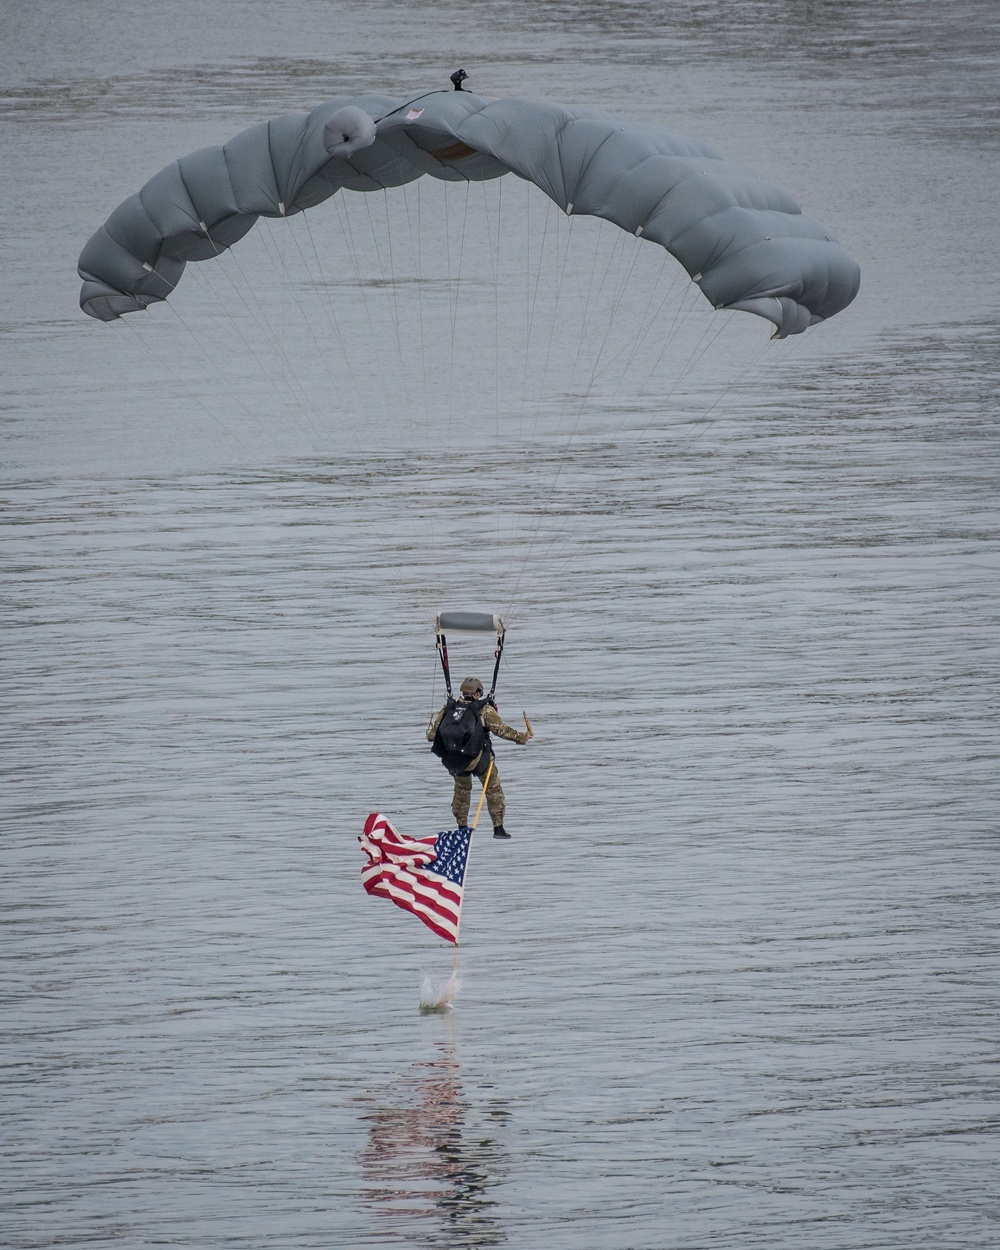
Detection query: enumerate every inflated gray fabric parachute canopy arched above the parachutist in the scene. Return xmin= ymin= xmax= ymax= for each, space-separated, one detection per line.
xmin=79 ymin=91 xmax=860 ymax=338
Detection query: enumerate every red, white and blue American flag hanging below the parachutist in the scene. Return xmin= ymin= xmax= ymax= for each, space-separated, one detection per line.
xmin=358 ymin=811 xmax=473 ymax=943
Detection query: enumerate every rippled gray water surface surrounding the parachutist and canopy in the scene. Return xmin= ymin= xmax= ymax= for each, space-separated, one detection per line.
xmin=0 ymin=0 xmax=1000 ymax=1250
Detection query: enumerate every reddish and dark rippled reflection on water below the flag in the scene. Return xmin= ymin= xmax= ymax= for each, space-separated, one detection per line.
xmin=359 ymin=1043 xmax=508 ymax=1248
